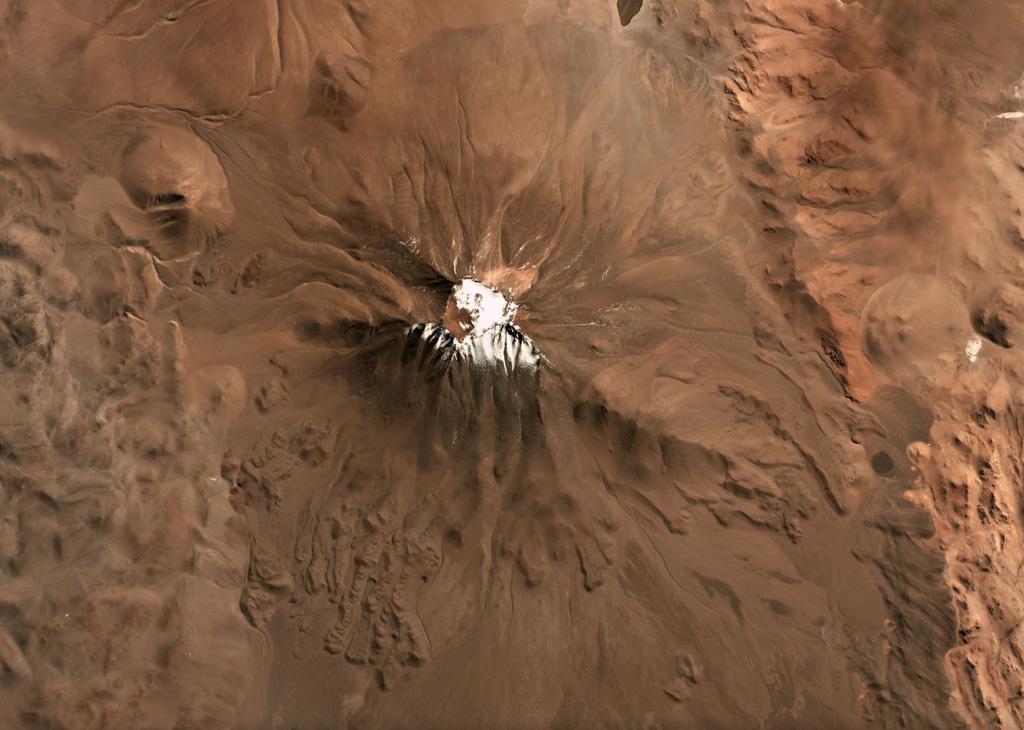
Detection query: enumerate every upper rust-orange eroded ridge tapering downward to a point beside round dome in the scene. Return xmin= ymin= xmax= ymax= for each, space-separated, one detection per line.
xmin=708 ymin=2 xmax=967 ymax=400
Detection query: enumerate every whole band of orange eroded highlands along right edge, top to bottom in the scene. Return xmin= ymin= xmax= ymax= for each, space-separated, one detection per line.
xmin=709 ymin=1 xmax=1021 ymax=727
